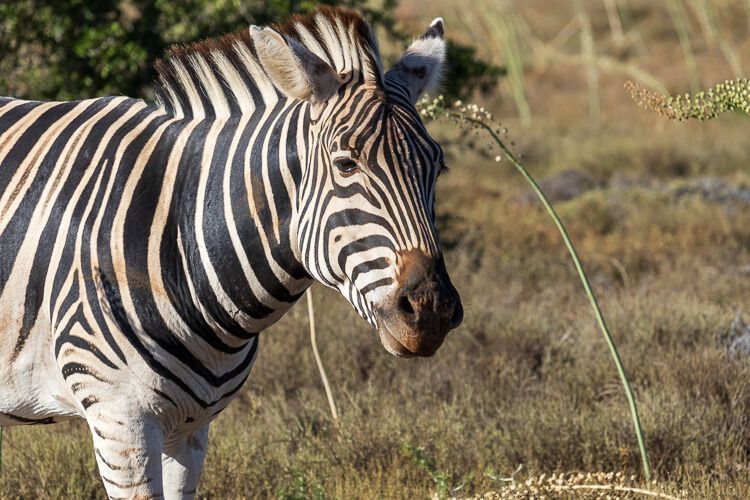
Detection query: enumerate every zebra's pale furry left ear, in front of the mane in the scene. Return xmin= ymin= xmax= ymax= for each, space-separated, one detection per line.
xmin=250 ymin=26 xmax=342 ymax=102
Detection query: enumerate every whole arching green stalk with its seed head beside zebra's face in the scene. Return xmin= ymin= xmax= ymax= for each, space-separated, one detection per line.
xmin=420 ymin=96 xmax=651 ymax=481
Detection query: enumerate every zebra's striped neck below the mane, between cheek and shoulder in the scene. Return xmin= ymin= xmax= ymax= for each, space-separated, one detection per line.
xmin=156 ymin=101 xmax=312 ymax=348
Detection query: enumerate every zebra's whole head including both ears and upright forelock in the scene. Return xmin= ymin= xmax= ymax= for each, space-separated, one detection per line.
xmin=251 ymin=9 xmax=463 ymax=356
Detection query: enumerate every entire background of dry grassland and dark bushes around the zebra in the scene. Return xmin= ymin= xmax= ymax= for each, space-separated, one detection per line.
xmin=0 ymin=0 xmax=750 ymax=500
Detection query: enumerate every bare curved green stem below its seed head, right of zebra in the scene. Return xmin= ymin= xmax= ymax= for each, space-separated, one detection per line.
xmin=458 ymin=113 xmax=651 ymax=481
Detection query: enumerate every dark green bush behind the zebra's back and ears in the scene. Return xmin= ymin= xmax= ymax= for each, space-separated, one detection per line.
xmin=0 ymin=0 xmax=501 ymax=100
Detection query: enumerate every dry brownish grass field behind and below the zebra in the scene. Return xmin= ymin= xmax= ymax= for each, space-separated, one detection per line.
xmin=0 ymin=0 xmax=750 ymax=499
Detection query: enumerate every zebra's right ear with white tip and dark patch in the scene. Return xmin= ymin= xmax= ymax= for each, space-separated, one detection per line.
xmin=385 ymin=17 xmax=445 ymax=103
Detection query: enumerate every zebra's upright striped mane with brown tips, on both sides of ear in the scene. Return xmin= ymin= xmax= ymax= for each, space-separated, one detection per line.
xmin=155 ymin=7 xmax=382 ymax=118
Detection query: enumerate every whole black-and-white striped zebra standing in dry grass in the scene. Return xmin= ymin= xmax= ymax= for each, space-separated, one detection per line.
xmin=0 ymin=7 xmax=463 ymax=498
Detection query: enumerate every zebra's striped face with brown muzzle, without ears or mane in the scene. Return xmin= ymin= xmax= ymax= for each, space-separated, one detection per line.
xmin=303 ymin=93 xmax=463 ymax=356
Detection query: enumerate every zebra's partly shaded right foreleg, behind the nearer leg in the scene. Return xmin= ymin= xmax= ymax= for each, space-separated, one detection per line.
xmin=161 ymin=425 xmax=208 ymax=500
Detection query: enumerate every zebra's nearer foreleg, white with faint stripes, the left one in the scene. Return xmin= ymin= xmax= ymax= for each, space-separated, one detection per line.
xmin=88 ymin=414 xmax=164 ymax=500
